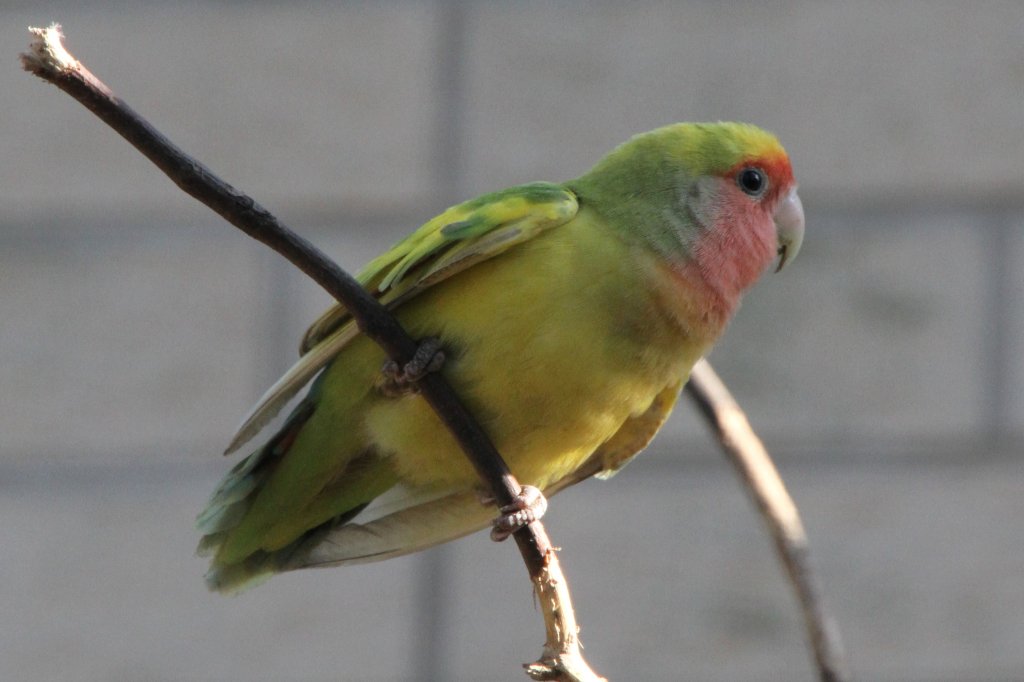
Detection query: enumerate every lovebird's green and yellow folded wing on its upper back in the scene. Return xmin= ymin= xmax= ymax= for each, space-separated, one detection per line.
xmin=225 ymin=182 xmax=579 ymax=454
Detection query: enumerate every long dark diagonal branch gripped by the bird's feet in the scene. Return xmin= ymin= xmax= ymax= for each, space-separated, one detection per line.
xmin=20 ymin=24 xmax=601 ymax=682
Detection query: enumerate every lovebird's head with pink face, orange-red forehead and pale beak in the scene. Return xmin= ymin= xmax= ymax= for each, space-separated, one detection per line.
xmin=578 ymin=123 xmax=804 ymax=300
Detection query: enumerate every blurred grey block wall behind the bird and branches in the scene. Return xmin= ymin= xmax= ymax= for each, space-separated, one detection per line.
xmin=0 ymin=0 xmax=1024 ymax=682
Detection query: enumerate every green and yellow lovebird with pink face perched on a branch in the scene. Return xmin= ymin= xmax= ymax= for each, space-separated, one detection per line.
xmin=197 ymin=122 xmax=804 ymax=592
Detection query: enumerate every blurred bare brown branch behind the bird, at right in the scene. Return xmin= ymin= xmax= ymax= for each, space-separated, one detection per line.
xmin=686 ymin=359 xmax=850 ymax=682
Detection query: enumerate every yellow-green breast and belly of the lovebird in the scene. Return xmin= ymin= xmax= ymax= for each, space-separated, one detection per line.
xmin=360 ymin=204 xmax=710 ymax=488
